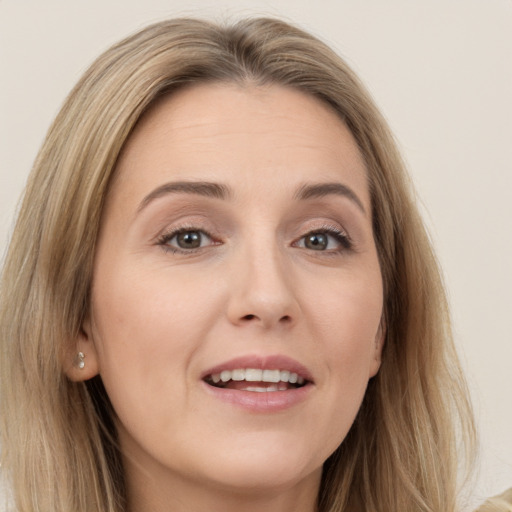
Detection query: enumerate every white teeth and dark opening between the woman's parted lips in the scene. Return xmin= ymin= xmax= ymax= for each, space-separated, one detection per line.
xmin=203 ymin=368 xmax=310 ymax=393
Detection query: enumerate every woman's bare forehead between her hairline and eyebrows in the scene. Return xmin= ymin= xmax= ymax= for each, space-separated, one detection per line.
xmin=113 ymin=84 xmax=369 ymax=210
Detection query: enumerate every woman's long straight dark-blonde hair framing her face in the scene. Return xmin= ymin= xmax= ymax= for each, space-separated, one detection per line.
xmin=0 ymin=19 xmax=474 ymax=512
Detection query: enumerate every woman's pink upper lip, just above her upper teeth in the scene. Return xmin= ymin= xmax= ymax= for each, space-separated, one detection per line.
xmin=201 ymin=354 xmax=313 ymax=382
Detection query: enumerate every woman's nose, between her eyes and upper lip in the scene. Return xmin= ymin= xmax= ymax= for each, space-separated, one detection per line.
xmin=227 ymin=240 xmax=300 ymax=329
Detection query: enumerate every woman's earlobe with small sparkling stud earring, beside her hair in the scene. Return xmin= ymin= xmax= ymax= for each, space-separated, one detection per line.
xmin=64 ymin=320 xmax=99 ymax=382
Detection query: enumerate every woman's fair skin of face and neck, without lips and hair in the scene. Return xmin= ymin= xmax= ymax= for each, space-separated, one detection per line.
xmin=69 ymin=85 xmax=384 ymax=512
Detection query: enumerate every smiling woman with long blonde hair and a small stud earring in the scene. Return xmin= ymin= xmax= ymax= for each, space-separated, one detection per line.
xmin=0 ymin=19 xmax=473 ymax=512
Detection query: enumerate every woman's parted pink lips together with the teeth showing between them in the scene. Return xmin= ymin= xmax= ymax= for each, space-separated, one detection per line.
xmin=201 ymin=355 xmax=313 ymax=412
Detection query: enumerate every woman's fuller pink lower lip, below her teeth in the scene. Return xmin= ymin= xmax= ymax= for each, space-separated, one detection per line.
xmin=203 ymin=382 xmax=313 ymax=413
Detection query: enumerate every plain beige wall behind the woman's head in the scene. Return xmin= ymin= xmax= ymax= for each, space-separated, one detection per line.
xmin=0 ymin=0 xmax=512 ymax=506
